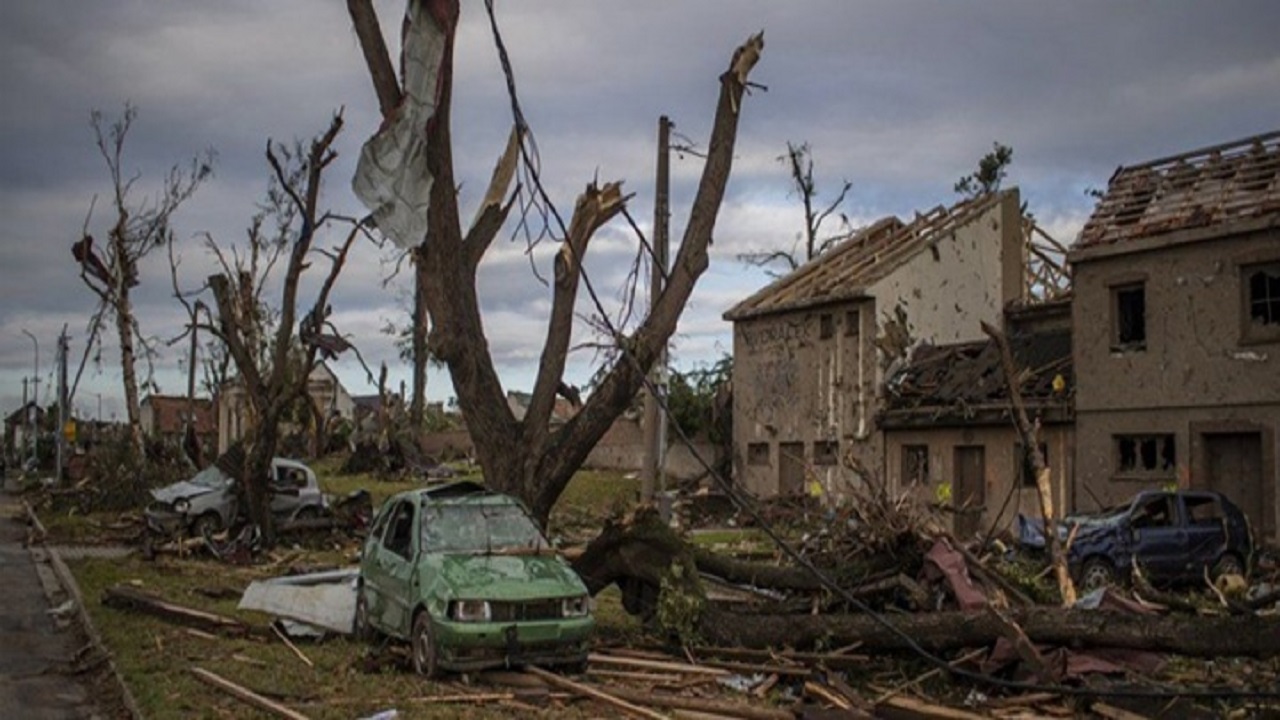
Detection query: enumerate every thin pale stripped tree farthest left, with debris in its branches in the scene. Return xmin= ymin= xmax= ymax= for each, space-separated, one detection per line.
xmin=72 ymin=105 xmax=212 ymax=457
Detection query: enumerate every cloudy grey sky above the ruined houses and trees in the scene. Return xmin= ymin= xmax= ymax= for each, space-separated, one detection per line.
xmin=0 ymin=0 xmax=1280 ymax=418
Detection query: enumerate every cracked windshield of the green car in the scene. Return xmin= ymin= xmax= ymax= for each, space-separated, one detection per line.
xmin=422 ymin=505 xmax=548 ymax=553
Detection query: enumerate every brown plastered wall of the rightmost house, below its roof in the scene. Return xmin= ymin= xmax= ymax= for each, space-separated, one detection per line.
xmin=1071 ymin=228 xmax=1280 ymax=537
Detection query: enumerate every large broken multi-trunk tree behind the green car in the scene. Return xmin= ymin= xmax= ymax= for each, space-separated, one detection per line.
xmin=347 ymin=0 xmax=764 ymax=521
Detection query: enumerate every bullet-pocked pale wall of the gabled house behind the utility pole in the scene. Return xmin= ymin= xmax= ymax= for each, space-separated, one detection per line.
xmin=733 ymin=192 xmax=1023 ymax=501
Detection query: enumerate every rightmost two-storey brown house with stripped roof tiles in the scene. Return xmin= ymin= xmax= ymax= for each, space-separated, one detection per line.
xmin=1068 ymin=132 xmax=1280 ymax=541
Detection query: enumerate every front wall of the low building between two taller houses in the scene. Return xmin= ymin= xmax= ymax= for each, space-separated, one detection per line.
xmin=884 ymin=425 xmax=1075 ymax=532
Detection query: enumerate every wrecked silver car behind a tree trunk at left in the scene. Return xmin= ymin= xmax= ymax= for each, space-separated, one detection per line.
xmin=145 ymin=457 xmax=329 ymax=536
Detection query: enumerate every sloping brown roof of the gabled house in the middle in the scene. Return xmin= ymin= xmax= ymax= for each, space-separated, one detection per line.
xmin=724 ymin=190 xmax=1016 ymax=320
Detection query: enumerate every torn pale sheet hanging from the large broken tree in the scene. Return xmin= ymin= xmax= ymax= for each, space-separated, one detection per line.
xmin=351 ymin=0 xmax=454 ymax=247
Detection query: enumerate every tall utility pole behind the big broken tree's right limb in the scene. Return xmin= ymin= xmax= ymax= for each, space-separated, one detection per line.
xmin=640 ymin=115 xmax=672 ymax=501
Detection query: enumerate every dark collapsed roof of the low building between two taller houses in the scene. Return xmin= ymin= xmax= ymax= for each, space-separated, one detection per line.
xmin=881 ymin=329 xmax=1075 ymax=428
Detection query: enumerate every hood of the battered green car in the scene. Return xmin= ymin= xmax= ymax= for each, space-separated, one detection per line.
xmin=429 ymin=553 xmax=586 ymax=601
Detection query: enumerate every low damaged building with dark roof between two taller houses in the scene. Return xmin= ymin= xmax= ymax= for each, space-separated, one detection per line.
xmin=878 ymin=296 xmax=1075 ymax=538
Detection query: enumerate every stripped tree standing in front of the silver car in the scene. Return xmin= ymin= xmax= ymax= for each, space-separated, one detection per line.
xmin=174 ymin=114 xmax=365 ymax=544
